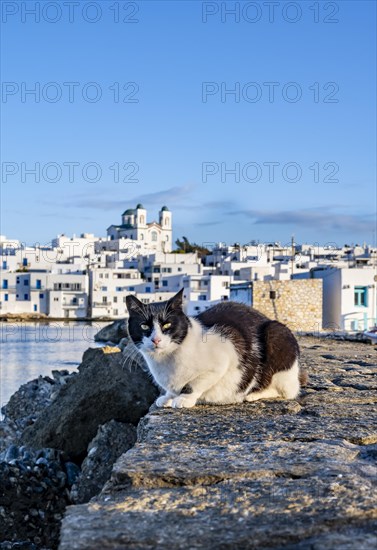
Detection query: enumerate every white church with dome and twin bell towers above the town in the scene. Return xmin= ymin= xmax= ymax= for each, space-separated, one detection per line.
xmin=107 ymin=204 xmax=173 ymax=252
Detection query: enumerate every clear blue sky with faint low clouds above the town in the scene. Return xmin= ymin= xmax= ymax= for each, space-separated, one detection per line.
xmin=1 ymin=0 xmax=376 ymax=245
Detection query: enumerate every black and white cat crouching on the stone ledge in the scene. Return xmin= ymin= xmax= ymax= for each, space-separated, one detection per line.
xmin=126 ymin=289 xmax=301 ymax=408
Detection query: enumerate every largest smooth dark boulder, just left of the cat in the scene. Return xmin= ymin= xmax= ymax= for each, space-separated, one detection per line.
xmin=22 ymin=348 xmax=159 ymax=459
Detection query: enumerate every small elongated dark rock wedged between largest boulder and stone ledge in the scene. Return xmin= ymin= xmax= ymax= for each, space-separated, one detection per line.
xmin=71 ymin=420 xmax=136 ymax=503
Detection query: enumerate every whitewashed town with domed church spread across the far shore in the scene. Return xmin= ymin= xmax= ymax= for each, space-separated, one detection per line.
xmin=0 ymin=209 xmax=377 ymax=331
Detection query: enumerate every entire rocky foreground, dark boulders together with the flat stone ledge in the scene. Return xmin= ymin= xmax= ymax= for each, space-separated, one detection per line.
xmin=0 ymin=334 xmax=377 ymax=550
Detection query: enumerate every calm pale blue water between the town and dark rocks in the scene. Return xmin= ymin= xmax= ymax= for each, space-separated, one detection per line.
xmin=0 ymin=322 xmax=108 ymax=406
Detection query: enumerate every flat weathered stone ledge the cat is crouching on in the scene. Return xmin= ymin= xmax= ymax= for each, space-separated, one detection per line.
xmin=60 ymin=338 xmax=377 ymax=550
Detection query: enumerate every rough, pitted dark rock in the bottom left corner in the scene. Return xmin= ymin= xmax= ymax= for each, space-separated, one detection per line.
xmin=0 ymin=445 xmax=71 ymax=550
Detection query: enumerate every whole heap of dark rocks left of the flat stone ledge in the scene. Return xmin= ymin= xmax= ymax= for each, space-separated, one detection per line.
xmin=0 ymin=346 xmax=158 ymax=550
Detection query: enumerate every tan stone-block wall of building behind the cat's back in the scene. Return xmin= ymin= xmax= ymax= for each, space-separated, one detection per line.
xmin=253 ymin=279 xmax=322 ymax=332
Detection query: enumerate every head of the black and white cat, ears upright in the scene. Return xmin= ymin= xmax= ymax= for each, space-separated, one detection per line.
xmin=126 ymin=289 xmax=190 ymax=359
